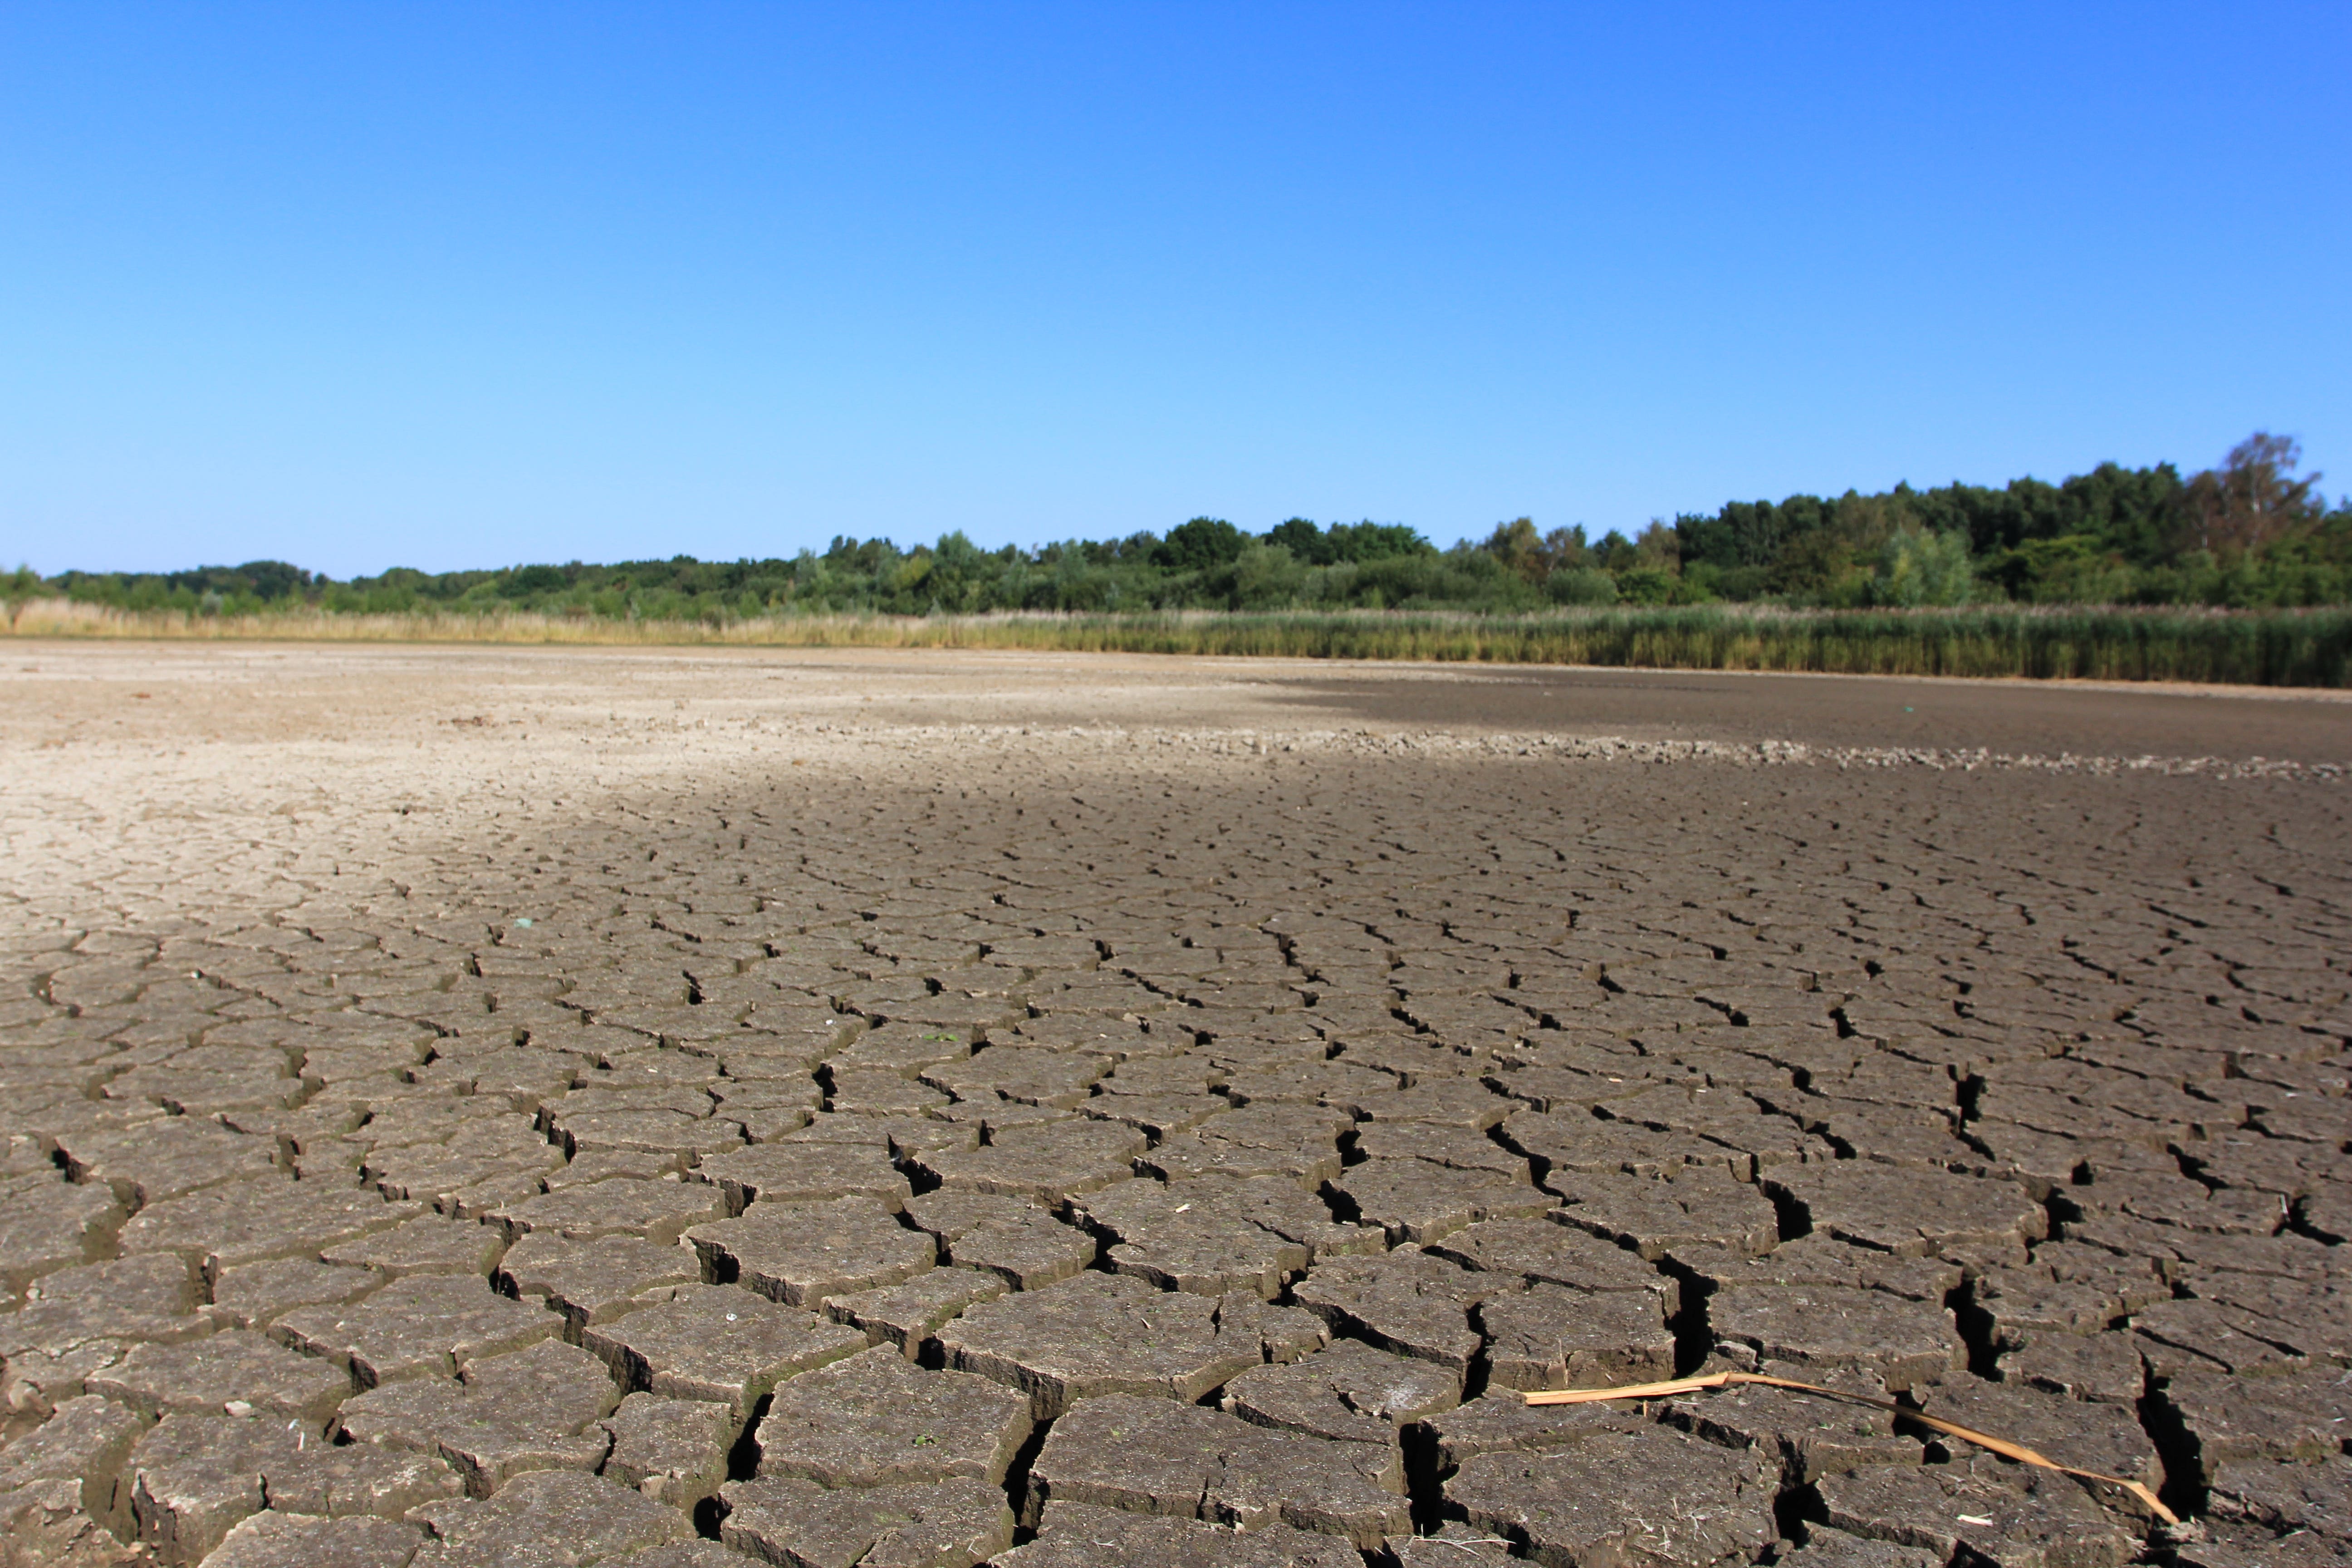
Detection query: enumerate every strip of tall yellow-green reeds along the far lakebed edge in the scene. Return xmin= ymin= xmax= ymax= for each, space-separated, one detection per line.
xmin=7 ymin=599 xmax=2352 ymax=686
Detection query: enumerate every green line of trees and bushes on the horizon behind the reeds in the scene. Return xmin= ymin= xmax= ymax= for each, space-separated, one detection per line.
xmin=0 ymin=432 xmax=2352 ymax=618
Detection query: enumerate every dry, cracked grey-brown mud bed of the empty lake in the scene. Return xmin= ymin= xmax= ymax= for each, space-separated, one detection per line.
xmin=0 ymin=649 xmax=2352 ymax=1568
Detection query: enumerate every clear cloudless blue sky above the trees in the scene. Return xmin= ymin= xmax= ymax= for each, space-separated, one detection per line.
xmin=0 ymin=0 xmax=2352 ymax=576
